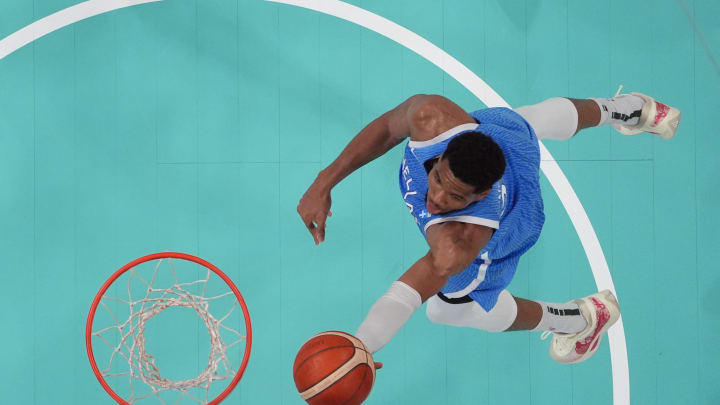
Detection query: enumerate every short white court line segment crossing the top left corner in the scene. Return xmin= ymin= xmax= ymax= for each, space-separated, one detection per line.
xmin=0 ymin=0 xmax=162 ymax=59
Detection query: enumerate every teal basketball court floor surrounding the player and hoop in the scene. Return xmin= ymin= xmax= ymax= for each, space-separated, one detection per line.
xmin=0 ymin=0 xmax=720 ymax=405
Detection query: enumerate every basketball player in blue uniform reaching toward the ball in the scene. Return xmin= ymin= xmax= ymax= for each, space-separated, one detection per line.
xmin=297 ymin=91 xmax=680 ymax=363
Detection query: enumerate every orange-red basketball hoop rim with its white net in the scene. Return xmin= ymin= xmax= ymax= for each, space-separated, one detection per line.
xmin=85 ymin=252 xmax=252 ymax=405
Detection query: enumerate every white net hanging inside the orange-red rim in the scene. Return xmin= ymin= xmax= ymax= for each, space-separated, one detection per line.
xmin=92 ymin=258 xmax=246 ymax=404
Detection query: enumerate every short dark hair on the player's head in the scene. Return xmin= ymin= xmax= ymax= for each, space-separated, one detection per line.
xmin=442 ymin=132 xmax=505 ymax=193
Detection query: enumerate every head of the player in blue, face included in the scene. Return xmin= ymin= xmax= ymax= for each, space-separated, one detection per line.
xmin=427 ymin=132 xmax=505 ymax=214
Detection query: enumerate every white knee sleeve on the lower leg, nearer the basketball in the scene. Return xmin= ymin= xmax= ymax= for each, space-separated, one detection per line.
xmin=426 ymin=290 xmax=517 ymax=332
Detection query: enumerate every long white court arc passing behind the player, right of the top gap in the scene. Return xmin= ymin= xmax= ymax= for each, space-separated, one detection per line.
xmin=266 ymin=0 xmax=630 ymax=405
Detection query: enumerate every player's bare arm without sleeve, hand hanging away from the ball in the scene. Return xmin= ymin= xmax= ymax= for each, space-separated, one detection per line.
xmin=297 ymin=95 xmax=432 ymax=245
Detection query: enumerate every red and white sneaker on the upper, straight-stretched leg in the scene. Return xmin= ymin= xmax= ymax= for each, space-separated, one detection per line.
xmin=613 ymin=85 xmax=682 ymax=139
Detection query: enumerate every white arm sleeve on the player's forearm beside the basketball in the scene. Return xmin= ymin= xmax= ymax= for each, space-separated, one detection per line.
xmin=355 ymin=281 xmax=422 ymax=353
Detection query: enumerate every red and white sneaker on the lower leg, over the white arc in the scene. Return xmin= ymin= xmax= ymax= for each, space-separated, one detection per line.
xmin=542 ymin=290 xmax=620 ymax=363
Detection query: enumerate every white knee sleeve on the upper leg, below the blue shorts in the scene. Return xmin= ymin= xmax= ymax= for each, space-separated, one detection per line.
xmin=515 ymin=97 xmax=578 ymax=141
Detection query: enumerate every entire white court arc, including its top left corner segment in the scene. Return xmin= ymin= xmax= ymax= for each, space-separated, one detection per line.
xmin=0 ymin=0 xmax=630 ymax=405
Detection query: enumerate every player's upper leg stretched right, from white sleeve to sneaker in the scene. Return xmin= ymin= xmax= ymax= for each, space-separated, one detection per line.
xmin=515 ymin=93 xmax=681 ymax=140
